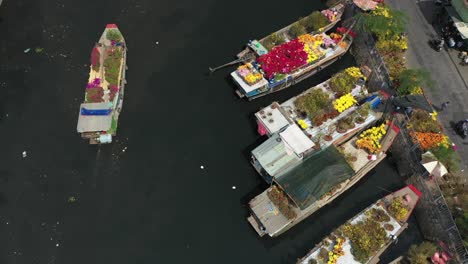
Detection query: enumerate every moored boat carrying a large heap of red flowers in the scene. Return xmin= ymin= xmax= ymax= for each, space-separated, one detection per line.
xmin=231 ymin=27 xmax=354 ymax=100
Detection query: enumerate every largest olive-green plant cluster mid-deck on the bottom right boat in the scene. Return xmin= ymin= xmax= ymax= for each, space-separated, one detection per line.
xmin=343 ymin=219 xmax=388 ymax=263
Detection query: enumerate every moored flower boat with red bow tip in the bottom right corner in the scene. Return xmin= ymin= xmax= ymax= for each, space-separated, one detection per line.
xmin=297 ymin=185 xmax=422 ymax=264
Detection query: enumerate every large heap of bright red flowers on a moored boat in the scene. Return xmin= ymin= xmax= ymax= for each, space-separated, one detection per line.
xmin=258 ymin=39 xmax=308 ymax=79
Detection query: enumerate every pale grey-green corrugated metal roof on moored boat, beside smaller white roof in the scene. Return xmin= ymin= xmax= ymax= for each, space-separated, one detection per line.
xmin=252 ymin=134 xmax=301 ymax=177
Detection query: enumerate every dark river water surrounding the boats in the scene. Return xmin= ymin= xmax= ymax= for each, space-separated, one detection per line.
xmin=0 ymin=0 xmax=421 ymax=264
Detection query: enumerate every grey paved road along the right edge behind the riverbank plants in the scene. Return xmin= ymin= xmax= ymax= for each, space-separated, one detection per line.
xmin=387 ymin=0 xmax=468 ymax=172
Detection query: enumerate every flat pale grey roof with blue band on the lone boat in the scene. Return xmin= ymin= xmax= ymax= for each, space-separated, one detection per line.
xmin=76 ymin=103 xmax=112 ymax=133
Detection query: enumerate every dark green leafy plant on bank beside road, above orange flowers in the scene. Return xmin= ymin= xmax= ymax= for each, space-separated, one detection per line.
xmin=397 ymin=69 xmax=433 ymax=95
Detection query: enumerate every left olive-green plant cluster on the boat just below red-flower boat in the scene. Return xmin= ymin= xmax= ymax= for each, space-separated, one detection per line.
xmin=294 ymin=89 xmax=330 ymax=118
